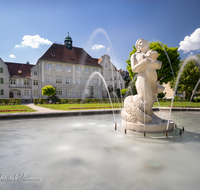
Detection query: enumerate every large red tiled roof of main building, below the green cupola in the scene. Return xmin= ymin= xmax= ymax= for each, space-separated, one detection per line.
xmin=39 ymin=43 xmax=102 ymax=67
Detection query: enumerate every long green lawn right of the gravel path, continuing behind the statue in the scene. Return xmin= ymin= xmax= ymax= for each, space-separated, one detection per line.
xmin=38 ymin=101 xmax=200 ymax=111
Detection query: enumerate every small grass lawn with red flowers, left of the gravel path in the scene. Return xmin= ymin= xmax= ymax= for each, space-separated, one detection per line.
xmin=0 ymin=105 xmax=36 ymax=114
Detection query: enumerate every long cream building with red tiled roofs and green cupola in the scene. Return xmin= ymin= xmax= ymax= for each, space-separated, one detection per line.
xmin=0 ymin=34 xmax=125 ymax=102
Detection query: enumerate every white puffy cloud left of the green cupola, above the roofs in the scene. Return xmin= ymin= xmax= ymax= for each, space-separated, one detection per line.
xmin=15 ymin=35 xmax=52 ymax=48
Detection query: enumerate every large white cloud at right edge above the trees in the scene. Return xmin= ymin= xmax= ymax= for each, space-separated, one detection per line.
xmin=178 ymin=28 xmax=200 ymax=53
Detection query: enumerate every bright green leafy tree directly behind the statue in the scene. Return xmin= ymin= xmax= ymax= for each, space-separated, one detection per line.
xmin=126 ymin=42 xmax=180 ymax=84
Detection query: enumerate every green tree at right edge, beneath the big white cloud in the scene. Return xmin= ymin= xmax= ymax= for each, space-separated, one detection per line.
xmin=170 ymin=55 xmax=200 ymax=99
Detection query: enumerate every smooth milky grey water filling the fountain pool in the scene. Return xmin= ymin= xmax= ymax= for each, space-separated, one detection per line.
xmin=0 ymin=111 xmax=200 ymax=190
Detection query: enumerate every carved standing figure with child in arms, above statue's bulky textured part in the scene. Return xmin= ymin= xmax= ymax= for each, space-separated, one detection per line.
xmin=131 ymin=38 xmax=164 ymax=116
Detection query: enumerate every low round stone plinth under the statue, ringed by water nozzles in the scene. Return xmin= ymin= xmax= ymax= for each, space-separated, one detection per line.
xmin=122 ymin=114 xmax=176 ymax=133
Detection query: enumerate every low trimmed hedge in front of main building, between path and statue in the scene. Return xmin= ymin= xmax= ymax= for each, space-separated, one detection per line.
xmin=33 ymin=98 xmax=124 ymax=104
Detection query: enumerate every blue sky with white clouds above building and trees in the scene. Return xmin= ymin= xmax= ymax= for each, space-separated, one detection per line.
xmin=0 ymin=0 xmax=200 ymax=69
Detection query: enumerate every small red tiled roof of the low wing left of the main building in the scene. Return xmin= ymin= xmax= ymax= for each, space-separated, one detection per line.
xmin=5 ymin=62 xmax=34 ymax=77
